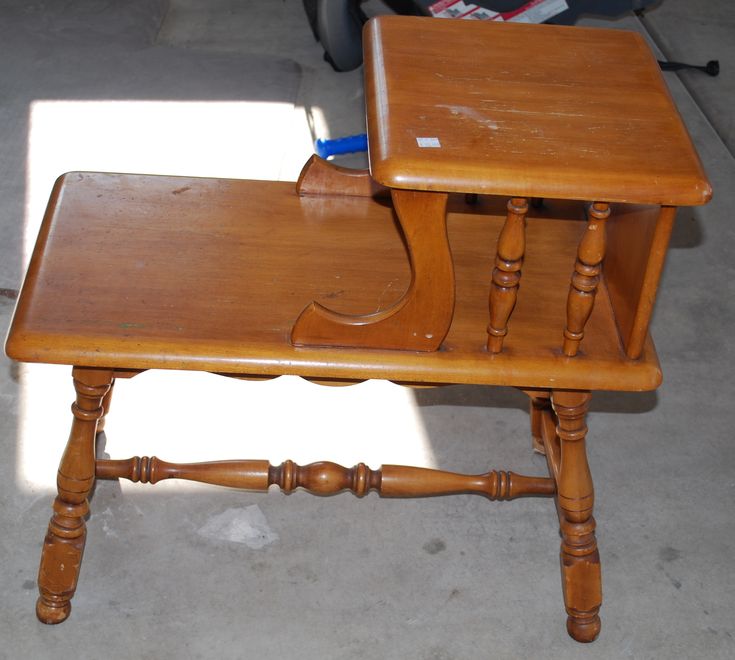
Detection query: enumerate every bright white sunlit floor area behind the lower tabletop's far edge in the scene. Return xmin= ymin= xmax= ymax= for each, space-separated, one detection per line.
xmin=24 ymin=100 xmax=319 ymax=262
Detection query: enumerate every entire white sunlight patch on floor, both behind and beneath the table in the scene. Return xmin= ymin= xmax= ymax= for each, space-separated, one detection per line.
xmin=17 ymin=96 xmax=434 ymax=490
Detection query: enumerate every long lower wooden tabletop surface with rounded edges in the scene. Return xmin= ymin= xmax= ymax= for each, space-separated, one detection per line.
xmin=6 ymin=173 xmax=661 ymax=390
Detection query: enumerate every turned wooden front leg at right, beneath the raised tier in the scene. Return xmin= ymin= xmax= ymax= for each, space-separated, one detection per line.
xmin=551 ymin=391 xmax=602 ymax=642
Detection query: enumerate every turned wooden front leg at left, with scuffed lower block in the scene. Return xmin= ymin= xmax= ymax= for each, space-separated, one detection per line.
xmin=36 ymin=367 xmax=113 ymax=623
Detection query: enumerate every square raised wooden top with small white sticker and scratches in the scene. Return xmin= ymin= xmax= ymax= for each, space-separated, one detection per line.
xmin=364 ymin=16 xmax=712 ymax=206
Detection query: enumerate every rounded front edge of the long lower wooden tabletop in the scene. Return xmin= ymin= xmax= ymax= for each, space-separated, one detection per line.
xmin=5 ymin=329 xmax=663 ymax=391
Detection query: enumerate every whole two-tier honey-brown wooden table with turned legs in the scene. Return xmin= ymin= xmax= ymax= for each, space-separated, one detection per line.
xmin=6 ymin=16 xmax=711 ymax=641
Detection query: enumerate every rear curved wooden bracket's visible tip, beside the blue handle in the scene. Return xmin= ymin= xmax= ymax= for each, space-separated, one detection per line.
xmin=296 ymin=154 xmax=388 ymax=197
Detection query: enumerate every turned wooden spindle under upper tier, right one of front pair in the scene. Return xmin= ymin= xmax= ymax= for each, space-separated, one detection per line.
xmin=562 ymin=202 xmax=610 ymax=357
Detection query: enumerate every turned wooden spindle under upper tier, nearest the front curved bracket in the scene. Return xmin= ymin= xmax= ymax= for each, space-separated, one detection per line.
xmin=487 ymin=197 xmax=528 ymax=353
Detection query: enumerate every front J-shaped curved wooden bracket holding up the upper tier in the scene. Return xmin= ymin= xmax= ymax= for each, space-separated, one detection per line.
xmin=291 ymin=190 xmax=454 ymax=351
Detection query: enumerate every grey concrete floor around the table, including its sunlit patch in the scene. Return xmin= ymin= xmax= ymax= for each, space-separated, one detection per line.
xmin=0 ymin=0 xmax=735 ymax=660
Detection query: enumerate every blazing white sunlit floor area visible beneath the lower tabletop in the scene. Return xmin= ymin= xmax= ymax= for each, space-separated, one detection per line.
xmin=18 ymin=365 xmax=436 ymax=490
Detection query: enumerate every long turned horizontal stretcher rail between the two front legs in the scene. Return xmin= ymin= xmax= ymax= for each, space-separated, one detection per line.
xmin=96 ymin=456 xmax=556 ymax=500
